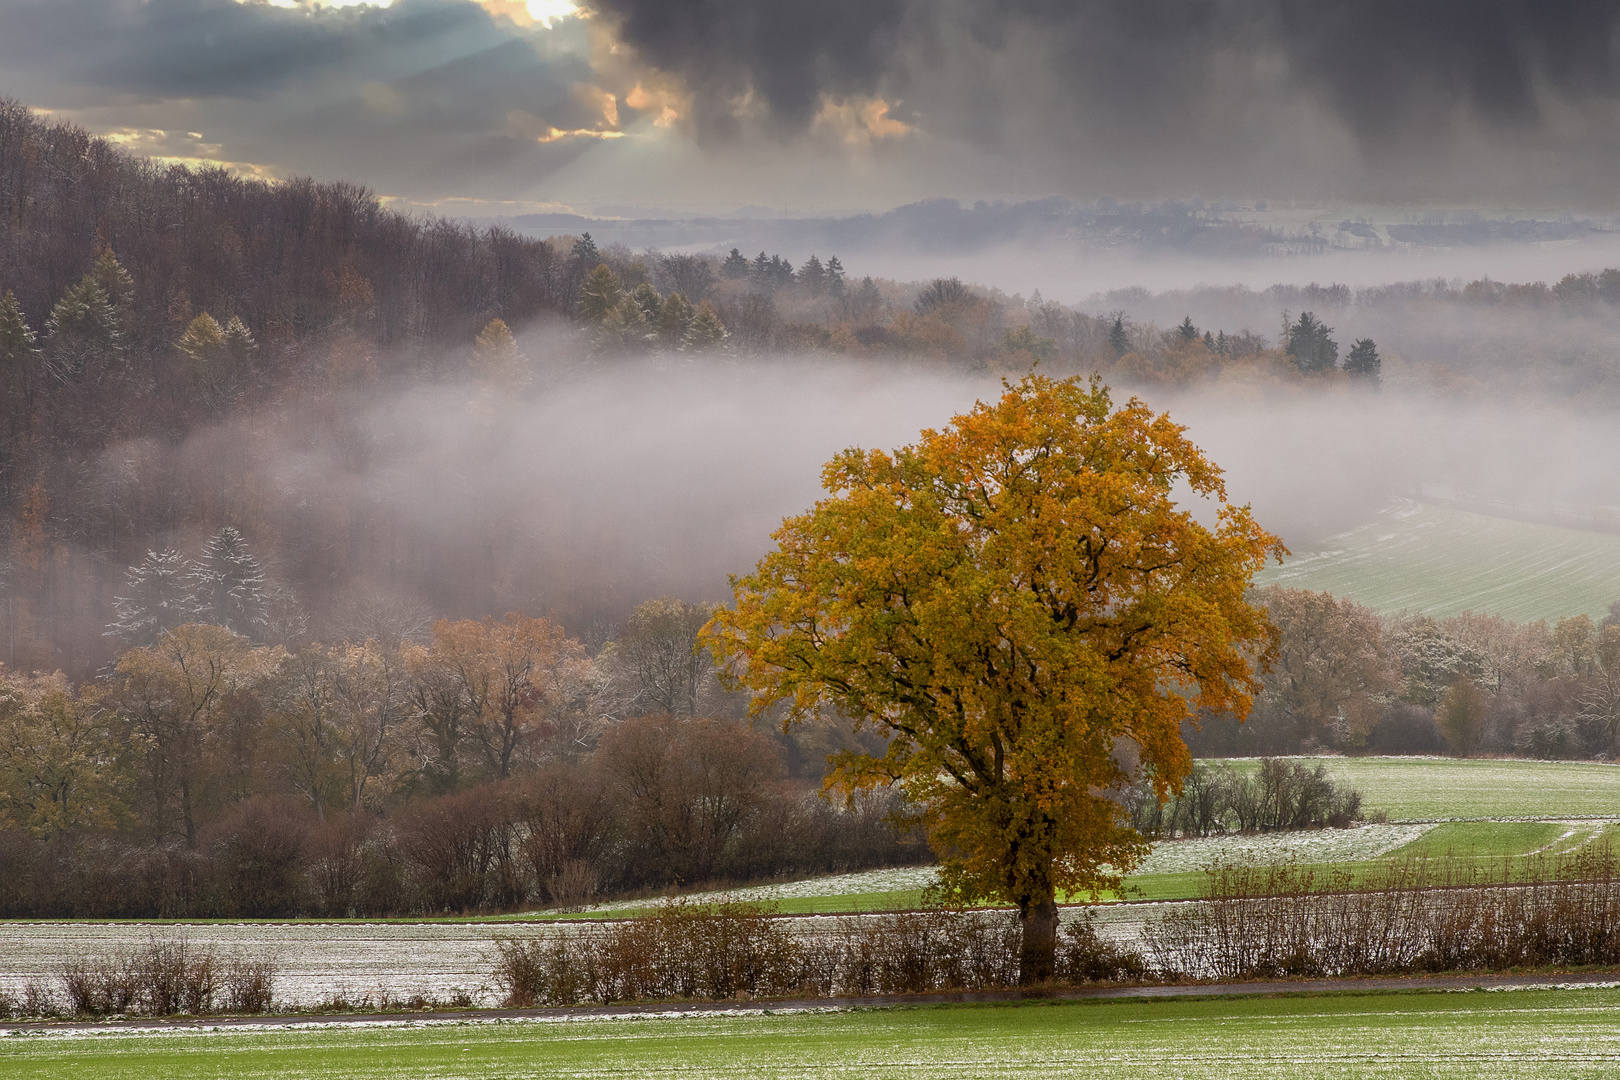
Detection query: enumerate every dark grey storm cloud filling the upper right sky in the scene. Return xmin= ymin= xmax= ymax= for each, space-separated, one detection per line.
xmin=593 ymin=0 xmax=1620 ymax=180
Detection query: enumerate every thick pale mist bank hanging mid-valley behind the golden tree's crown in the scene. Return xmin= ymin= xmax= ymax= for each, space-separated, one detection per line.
xmin=98 ymin=358 xmax=1620 ymax=641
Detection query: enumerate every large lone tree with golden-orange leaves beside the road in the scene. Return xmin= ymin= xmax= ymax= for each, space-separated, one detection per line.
xmin=705 ymin=376 xmax=1283 ymax=984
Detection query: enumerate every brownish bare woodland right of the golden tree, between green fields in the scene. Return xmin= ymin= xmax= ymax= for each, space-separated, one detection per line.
xmin=1186 ymin=586 xmax=1620 ymax=759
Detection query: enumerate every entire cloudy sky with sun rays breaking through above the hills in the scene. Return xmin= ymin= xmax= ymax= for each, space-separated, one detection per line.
xmin=0 ymin=0 xmax=1620 ymax=212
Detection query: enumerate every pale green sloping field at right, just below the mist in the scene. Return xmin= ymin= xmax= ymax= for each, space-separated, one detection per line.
xmin=1259 ymin=502 xmax=1620 ymax=622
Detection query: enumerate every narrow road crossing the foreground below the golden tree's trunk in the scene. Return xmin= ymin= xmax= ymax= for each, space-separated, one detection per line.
xmin=0 ymin=972 xmax=1620 ymax=1036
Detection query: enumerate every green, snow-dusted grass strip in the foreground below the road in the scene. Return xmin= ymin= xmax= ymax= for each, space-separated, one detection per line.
xmin=9 ymin=988 xmax=1620 ymax=1080
